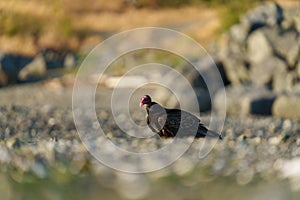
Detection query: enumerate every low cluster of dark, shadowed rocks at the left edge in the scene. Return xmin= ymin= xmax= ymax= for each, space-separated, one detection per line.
xmin=0 ymin=48 xmax=77 ymax=86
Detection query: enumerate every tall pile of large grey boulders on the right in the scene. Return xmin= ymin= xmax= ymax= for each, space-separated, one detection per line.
xmin=215 ymin=2 xmax=300 ymax=118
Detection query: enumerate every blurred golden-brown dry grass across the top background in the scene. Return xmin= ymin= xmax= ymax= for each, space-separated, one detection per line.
xmin=0 ymin=0 xmax=298 ymax=55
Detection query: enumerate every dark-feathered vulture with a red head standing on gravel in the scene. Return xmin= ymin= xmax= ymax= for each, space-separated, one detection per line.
xmin=140 ymin=95 xmax=223 ymax=140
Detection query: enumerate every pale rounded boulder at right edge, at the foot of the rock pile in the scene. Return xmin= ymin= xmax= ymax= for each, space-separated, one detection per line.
xmin=272 ymin=95 xmax=300 ymax=119
